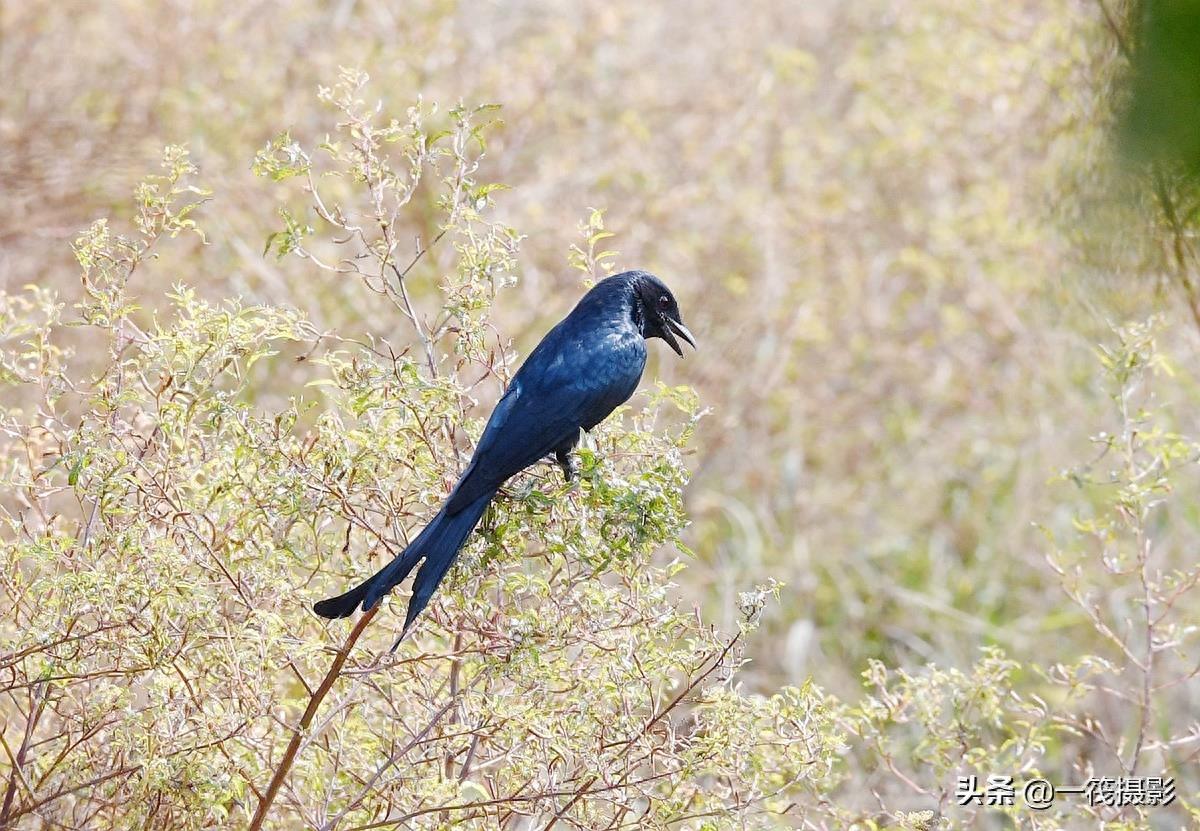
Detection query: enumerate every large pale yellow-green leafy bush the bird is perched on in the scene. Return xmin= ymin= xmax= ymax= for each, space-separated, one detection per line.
xmin=0 ymin=82 xmax=854 ymax=829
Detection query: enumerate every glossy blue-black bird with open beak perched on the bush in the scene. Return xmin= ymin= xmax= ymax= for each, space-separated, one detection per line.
xmin=313 ymin=271 xmax=696 ymax=632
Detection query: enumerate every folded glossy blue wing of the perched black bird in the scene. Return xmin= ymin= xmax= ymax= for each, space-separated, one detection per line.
xmin=446 ymin=327 xmax=646 ymax=513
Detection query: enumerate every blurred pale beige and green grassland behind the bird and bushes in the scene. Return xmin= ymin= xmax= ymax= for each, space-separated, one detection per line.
xmin=0 ymin=0 xmax=1196 ymax=717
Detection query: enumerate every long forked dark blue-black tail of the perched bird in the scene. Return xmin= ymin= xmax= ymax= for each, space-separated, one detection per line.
xmin=313 ymin=491 xmax=496 ymax=632
